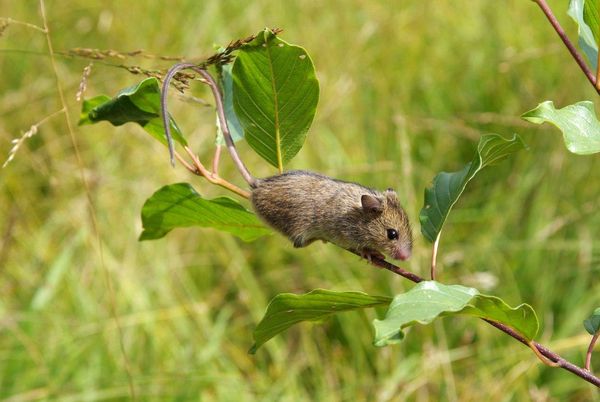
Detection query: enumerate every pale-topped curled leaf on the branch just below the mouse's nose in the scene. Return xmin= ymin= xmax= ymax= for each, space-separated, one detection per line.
xmin=373 ymin=281 xmax=539 ymax=346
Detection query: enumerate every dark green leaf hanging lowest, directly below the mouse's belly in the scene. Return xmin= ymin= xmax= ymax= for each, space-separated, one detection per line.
xmin=249 ymin=289 xmax=392 ymax=354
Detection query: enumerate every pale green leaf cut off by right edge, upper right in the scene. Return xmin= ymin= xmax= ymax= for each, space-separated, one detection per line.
xmin=521 ymin=101 xmax=600 ymax=155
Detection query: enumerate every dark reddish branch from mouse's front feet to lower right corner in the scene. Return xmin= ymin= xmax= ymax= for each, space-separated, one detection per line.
xmin=360 ymin=251 xmax=600 ymax=388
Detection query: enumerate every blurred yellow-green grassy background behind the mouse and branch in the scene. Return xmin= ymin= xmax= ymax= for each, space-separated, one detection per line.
xmin=0 ymin=0 xmax=600 ymax=401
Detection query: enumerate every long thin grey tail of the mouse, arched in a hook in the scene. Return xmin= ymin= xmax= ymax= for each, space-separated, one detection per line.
xmin=160 ymin=63 xmax=256 ymax=187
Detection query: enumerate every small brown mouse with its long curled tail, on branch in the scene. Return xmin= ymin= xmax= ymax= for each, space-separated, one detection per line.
xmin=161 ymin=63 xmax=412 ymax=260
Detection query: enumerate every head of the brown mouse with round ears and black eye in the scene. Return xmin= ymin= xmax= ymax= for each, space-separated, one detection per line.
xmin=360 ymin=189 xmax=412 ymax=260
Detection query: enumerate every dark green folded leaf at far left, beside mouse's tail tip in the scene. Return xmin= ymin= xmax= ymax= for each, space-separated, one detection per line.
xmin=79 ymin=78 xmax=187 ymax=145
